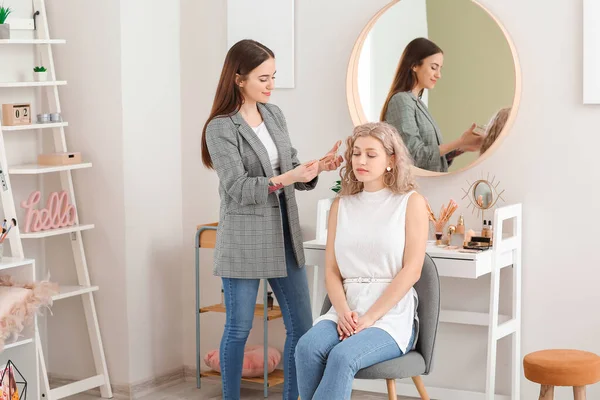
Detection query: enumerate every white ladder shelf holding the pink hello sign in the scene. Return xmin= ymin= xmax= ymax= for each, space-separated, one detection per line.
xmin=0 ymin=0 xmax=112 ymax=400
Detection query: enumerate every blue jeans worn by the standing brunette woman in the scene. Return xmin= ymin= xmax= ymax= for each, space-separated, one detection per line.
xmin=219 ymin=199 xmax=312 ymax=400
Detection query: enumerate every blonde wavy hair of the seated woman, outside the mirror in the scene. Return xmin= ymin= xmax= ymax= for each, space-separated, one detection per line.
xmin=339 ymin=122 xmax=417 ymax=196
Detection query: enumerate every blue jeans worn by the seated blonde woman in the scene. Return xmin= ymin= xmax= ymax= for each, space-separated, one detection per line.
xmin=296 ymin=320 xmax=414 ymax=400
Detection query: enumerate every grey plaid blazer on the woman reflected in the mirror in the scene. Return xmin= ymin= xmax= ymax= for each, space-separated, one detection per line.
xmin=385 ymin=92 xmax=448 ymax=172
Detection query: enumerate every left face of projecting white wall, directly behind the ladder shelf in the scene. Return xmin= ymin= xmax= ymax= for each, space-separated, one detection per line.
xmin=42 ymin=0 xmax=129 ymax=385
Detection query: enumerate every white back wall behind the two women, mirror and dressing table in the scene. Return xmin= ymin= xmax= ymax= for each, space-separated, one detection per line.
xmin=182 ymin=0 xmax=600 ymax=400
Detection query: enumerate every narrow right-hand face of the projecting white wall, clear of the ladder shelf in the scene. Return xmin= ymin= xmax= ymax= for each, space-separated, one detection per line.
xmin=121 ymin=0 xmax=182 ymax=383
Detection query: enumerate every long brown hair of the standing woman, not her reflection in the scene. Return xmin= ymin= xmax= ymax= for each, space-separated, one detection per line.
xmin=202 ymin=39 xmax=275 ymax=169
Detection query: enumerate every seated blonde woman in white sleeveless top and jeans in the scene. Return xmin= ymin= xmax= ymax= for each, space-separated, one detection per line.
xmin=296 ymin=122 xmax=428 ymax=400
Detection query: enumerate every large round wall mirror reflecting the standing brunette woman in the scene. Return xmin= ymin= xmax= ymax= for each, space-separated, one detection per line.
xmin=347 ymin=0 xmax=521 ymax=176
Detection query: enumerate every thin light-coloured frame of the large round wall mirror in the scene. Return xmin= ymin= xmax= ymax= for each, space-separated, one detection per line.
xmin=346 ymin=0 xmax=521 ymax=176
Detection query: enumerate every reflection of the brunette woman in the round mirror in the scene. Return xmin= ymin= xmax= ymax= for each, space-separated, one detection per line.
xmin=380 ymin=38 xmax=483 ymax=172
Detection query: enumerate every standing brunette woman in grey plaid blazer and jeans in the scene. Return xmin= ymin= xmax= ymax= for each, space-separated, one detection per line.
xmin=202 ymin=40 xmax=342 ymax=400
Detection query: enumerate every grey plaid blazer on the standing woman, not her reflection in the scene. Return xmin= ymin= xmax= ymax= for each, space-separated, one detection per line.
xmin=206 ymin=103 xmax=318 ymax=278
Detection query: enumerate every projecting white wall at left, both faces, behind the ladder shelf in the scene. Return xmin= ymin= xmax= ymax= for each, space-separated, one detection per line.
xmin=41 ymin=0 xmax=182 ymax=388
